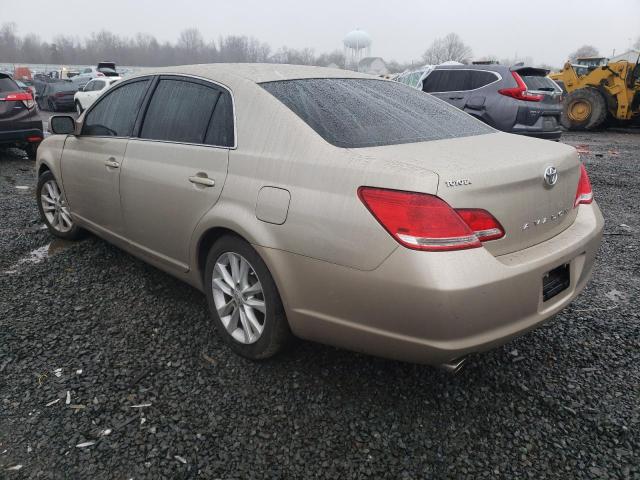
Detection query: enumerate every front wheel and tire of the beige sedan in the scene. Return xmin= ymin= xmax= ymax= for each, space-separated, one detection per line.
xmin=36 ymin=171 xmax=82 ymax=240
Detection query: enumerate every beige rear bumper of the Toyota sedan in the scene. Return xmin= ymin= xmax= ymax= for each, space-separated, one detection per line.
xmin=256 ymin=202 xmax=604 ymax=364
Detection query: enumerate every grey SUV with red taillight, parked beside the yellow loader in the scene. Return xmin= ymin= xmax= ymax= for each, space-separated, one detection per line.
xmin=422 ymin=64 xmax=562 ymax=140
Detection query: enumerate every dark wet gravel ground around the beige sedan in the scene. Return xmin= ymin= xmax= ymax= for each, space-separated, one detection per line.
xmin=0 ymin=131 xmax=640 ymax=479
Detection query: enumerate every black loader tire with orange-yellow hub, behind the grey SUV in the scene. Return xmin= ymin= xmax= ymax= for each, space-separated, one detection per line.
xmin=560 ymin=87 xmax=608 ymax=130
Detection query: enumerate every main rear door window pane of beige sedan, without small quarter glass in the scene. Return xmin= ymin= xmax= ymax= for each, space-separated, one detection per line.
xmin=140 ymin=79 xmax=220 ymax=143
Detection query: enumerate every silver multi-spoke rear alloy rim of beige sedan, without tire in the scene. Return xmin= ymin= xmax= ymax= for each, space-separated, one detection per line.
xmin=211 ymin=252 xmax=266 ymax=344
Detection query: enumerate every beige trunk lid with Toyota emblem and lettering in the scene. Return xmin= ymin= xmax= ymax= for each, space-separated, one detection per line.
xmin=358 ymin=133 xmax=580 ymax=255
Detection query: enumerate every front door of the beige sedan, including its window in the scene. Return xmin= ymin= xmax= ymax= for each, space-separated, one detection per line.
xmin=61 ymin=78 xmax=151 ymax=235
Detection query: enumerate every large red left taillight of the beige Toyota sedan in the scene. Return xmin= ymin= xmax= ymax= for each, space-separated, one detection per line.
xmin=358 ymin=187 xmax=504 ymax=251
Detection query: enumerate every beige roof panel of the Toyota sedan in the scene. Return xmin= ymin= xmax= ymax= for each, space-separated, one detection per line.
xmin=127 ymin=63 xmax=372 ymax=83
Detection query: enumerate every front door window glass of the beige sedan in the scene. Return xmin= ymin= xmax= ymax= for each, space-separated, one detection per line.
xmin=82 ymin=79 xmax=149 ymax=137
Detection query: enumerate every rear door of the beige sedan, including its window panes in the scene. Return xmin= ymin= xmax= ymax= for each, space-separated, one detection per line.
xmin=120 ymin=76 xmax=234 ymax=271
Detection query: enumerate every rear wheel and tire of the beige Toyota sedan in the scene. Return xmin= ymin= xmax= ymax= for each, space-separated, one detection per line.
xmin=205 ymin=235 xmax=292 ymax=360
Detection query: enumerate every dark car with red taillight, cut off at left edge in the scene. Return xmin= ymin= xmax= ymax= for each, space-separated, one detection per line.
xmin=0 ymin=73 xmax=43 ymax=158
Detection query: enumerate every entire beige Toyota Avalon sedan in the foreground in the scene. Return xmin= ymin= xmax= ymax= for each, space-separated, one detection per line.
xmin=37 ymin=64 xmax=603 ymax=370
